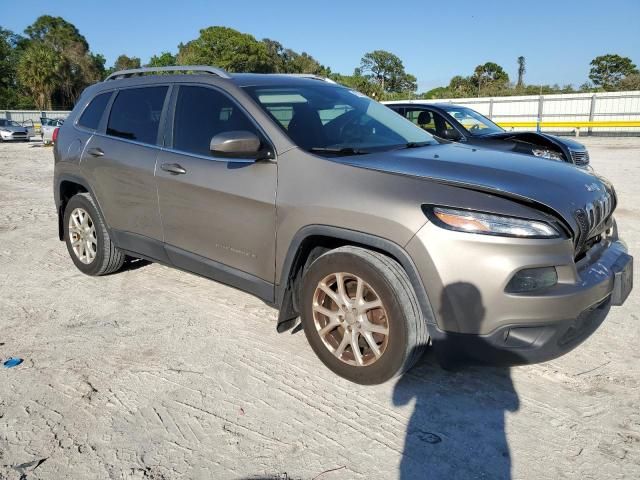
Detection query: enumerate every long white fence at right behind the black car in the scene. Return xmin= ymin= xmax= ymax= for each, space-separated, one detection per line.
xmin=388 ymin=91 xmax=640 ymax=135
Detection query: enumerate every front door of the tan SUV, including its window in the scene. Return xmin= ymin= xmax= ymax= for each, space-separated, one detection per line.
xmin=156 ymin=85 xmax=277 ymax=298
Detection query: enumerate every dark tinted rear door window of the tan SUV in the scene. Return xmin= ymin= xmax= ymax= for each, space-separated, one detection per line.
xmin=107 ymin=86 xmax=167 ymax=144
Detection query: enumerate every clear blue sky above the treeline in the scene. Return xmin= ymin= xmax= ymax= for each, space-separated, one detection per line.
xmin=0 ymin=0 xmax=640 ymax=91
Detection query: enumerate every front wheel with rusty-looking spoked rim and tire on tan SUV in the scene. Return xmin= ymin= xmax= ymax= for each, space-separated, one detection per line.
xmin=300 ymin=246 xmax=429 ymax=385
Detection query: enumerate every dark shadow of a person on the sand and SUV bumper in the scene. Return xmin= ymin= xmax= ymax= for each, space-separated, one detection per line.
xmin=393 ymin=283 xmax=519 ymax=480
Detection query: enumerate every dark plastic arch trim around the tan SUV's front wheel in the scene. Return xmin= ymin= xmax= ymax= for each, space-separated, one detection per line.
xmin=275 ymin=225 xmax=435 ymax=332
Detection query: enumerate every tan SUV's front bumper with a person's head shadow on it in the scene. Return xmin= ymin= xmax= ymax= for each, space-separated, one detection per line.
xmin=407 ymin=218 xmax=632 ymax=365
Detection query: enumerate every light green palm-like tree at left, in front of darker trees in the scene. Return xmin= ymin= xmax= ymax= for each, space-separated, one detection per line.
xmin=18 ymin=41 xmax=62 ymax=110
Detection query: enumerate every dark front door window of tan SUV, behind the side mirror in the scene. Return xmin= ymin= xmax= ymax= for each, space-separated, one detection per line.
xmin=173 ymin=86 xmax=262 ymax=156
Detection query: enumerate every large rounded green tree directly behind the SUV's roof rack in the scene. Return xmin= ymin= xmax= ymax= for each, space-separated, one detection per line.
xmin=178 ymin=27 xmax=274 ymax=73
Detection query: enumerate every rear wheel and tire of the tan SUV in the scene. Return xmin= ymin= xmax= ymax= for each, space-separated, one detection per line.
xmin=63 ymin=193 xmax=125 ymax=276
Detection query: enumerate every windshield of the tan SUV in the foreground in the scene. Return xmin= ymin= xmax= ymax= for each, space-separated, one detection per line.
xmin=244 ymin=84 xmax=437 ymax=155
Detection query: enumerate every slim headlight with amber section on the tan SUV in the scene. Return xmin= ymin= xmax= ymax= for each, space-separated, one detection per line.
xmin=423 ymin=207 xmax=560 ymax=238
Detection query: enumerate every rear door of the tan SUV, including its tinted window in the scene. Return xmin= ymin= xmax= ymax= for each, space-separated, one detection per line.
xmin=78 ymin=85 xmax=169 ymax=260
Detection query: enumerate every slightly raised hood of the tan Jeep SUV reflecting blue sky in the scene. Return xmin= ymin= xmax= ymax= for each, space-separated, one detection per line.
xmin=340 ymin=143 xmax=615 ymax=238
